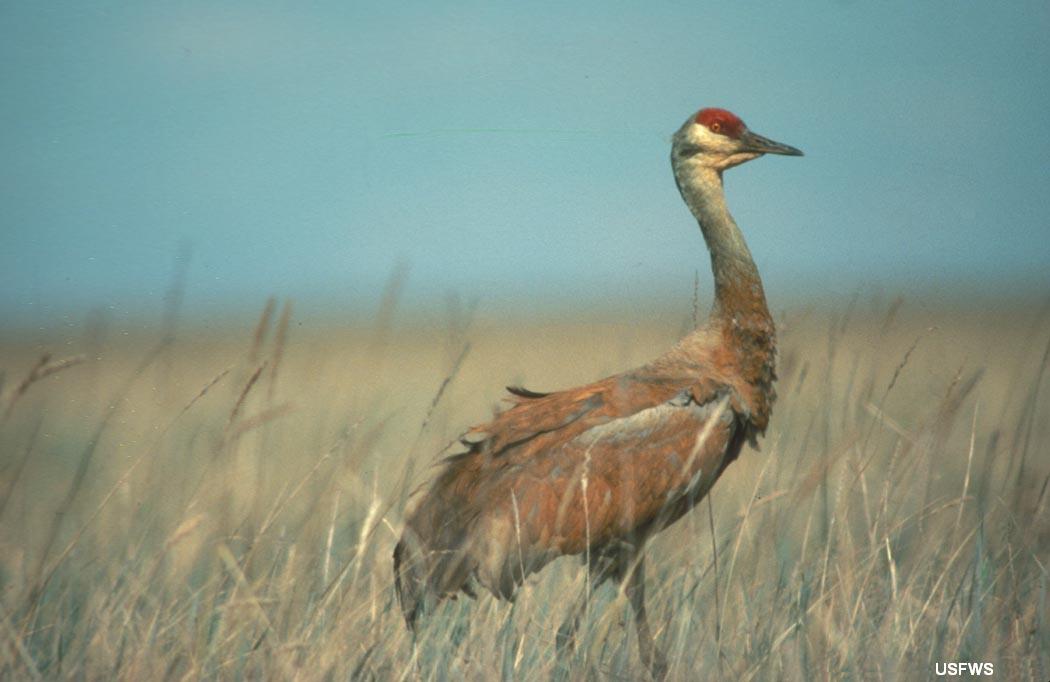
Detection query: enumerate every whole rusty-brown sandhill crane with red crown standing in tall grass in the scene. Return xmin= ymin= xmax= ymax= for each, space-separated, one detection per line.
xmin=394 ymin=108 xmax=802 ymax=678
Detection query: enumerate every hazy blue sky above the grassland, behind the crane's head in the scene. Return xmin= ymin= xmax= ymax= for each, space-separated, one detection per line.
xmin=0 ymin=0 xmax=1050 ymax=324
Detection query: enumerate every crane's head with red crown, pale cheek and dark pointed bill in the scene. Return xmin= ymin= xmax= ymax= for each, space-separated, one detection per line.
xmin=672 ymin=108 xmax=802 ymax=171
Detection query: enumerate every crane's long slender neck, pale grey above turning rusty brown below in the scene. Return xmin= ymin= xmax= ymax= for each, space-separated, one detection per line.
xmin=674 ymin=159 xmax=772 ymax=327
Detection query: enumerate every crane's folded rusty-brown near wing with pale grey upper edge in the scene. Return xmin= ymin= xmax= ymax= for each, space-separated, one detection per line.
xmin=459 ymin=379 xmax=744 ymax=596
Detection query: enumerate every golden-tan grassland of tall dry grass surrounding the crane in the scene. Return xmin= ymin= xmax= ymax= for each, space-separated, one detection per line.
xmin=0 ymin=301 xmax=1050 ymax=682
